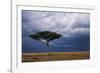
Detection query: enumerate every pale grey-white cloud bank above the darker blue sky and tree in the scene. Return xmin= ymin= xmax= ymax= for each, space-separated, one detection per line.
xmin=22 ymin=10 xmax=89 ymax=37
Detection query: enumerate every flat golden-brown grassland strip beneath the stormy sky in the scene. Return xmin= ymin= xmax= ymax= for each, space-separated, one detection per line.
xmin=22 ymin=51 xmax=90 ymax=62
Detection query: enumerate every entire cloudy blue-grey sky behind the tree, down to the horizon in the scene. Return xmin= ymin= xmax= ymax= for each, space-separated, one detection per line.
xmin=22 ymin=10 xmax=90 ymax=52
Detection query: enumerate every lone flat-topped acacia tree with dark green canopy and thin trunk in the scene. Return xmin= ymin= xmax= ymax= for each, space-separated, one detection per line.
xmin=29 ymin=31 xmax=62 ymax=55
